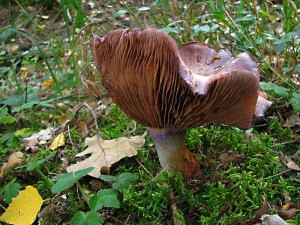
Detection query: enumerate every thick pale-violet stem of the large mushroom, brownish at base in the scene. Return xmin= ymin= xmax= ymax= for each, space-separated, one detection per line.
xmin=148 ymin=128 xmax=200 ymax=179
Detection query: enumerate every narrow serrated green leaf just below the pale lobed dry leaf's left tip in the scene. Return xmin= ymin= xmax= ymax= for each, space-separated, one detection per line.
xmin=51 ymin=167 xmax=94 ymax=194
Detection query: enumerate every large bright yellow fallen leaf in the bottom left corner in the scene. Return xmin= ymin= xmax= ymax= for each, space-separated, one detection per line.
xmin=0 ymin=186 xmax=43 ymax=225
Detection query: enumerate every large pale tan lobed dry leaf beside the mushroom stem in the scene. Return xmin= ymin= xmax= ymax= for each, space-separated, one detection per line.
xmin=67 ymin=135 xmax=145 ymax=178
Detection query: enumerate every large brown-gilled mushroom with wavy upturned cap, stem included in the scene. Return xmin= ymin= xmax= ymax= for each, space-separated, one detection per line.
xmin=90 ymin=28 xmax=271 ymax=178
